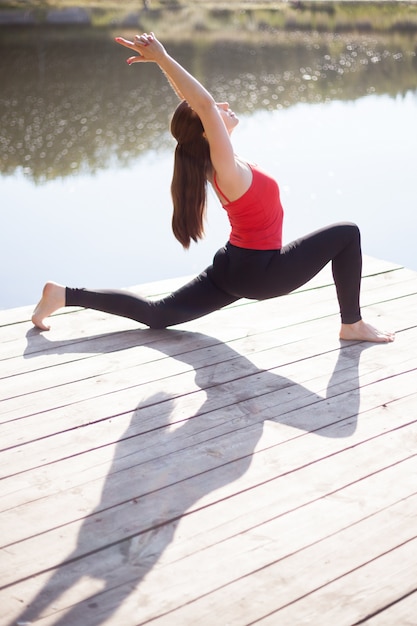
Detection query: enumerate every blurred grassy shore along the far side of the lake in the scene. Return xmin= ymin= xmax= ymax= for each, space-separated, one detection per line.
xmin=0 ymin=0 xmax=417 ymax=38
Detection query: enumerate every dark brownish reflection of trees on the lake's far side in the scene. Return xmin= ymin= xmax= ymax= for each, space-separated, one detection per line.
xmin=0 ymin=31 xmax=417 ymax=181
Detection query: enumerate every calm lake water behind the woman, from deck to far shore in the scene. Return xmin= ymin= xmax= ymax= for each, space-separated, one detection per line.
xmin=0 ymin=28 xmax=417 ymax=308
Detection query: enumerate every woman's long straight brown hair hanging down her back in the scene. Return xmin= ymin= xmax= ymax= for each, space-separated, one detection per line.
xmin=171 ymin=100 xmax=212 ymax=248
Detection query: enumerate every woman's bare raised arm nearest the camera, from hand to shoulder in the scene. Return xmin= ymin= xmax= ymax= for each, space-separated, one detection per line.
xmin=116 ymin=33 xmax=248 ymax=196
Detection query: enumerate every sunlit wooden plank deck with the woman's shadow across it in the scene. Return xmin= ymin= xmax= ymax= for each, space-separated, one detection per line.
xmin=0 ymin=258 xmax=417 ymax=626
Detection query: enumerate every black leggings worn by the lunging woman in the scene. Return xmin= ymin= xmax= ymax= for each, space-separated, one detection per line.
xmin=66 ymin=223 xmax=362 ymax=328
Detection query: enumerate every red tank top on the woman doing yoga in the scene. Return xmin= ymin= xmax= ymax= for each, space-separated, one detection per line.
xmin=213 ymin=164 xmax=284 ymax=250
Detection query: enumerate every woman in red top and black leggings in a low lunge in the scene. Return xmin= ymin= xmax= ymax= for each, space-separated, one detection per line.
xmin=32 ymin=33 xmax=394 ymax=342
